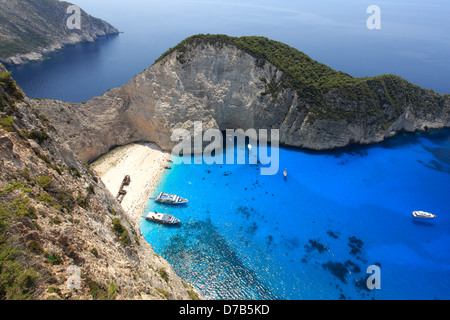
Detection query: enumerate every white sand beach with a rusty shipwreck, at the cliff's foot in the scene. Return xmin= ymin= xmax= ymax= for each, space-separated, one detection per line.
xmin=91 ymin=143 xmax=170 ymax=224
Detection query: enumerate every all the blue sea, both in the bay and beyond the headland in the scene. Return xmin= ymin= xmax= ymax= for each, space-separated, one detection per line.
xmin=4 ymin=0 xmax=450 ymax=299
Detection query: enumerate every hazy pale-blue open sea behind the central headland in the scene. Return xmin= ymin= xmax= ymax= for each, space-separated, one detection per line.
xmin=9 ymin=0 xmax=450 ymax=102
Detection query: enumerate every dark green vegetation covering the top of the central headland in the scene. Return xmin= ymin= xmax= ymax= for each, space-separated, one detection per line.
xmin=155 ymin=34 xmax=445 ymax=120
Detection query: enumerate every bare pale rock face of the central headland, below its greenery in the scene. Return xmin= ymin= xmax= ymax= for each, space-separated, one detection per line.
xmin=36 ymin=41 xmax=293 ymax=161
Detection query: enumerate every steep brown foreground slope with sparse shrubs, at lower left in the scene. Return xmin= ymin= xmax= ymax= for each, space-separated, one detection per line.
xmin=0 ymin=64 xmax=197 ymax=299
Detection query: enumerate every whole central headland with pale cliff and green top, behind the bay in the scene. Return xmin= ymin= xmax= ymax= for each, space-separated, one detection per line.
xmin=36 ymin=35 xmax=450 ymax=162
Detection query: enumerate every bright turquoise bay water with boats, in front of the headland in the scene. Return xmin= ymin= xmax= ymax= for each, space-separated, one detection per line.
xmin=140 ymin=130 xmax=450 ymax=299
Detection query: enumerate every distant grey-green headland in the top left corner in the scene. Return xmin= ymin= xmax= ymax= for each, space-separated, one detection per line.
xmin=0 ymin=0 xmax=119 ymax=65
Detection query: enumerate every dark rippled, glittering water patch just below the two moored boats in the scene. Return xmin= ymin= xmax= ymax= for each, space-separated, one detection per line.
xmin=162 ymin=219 xmax=279 ymax=300
